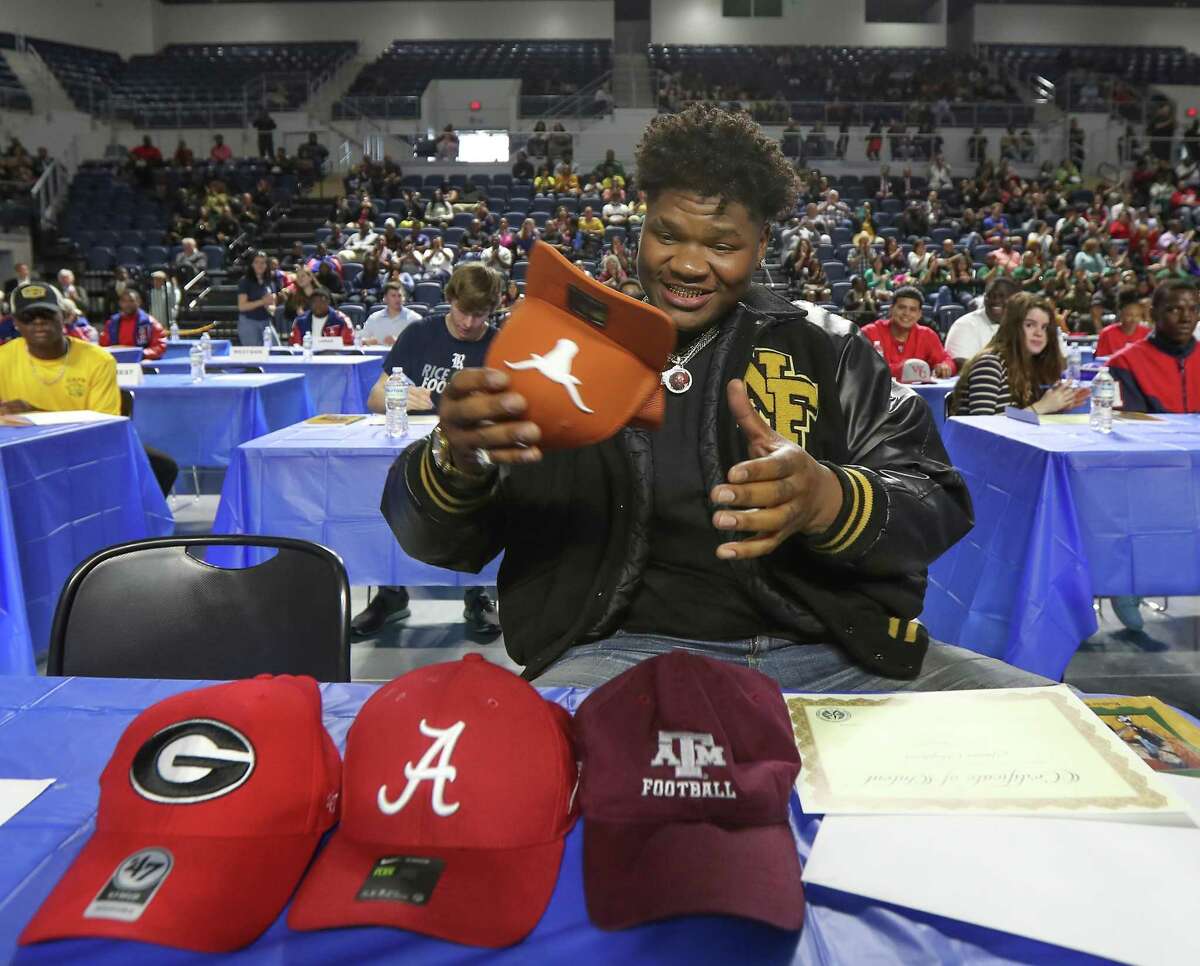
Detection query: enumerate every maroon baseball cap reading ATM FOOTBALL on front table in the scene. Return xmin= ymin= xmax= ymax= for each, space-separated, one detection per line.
xmin=575 ymin=650 xmax=804 ymax=930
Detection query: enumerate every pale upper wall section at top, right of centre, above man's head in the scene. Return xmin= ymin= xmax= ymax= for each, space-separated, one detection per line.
xmin=650 ymin=0 xmax=946 ymax=47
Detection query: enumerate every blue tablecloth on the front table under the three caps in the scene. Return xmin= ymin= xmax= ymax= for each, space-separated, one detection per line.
xmin=0 ymin=678 xmax=1142 ymax=966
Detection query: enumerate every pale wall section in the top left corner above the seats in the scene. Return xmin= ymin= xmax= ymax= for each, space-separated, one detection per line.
xmin=0 ymin=0 xmax=158 ymax=56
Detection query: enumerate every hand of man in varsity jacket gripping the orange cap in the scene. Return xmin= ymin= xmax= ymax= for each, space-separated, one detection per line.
xmin=438 ymin=368 xmax=541 ymax=473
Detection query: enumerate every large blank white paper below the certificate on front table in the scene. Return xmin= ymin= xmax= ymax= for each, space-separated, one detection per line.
xmin=804 ymin=816 xmax=1200 ymax=965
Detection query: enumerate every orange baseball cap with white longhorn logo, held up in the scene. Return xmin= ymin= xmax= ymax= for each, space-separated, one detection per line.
xmin=486 ymin=244 xmax=676 ymax=450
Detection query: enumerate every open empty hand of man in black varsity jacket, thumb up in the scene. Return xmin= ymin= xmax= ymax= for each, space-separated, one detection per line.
xmin=709 ymin=379 xmax=842 ymax=560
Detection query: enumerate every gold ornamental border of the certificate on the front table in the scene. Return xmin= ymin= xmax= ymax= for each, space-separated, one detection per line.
xmin=785 ymin=686 xmax=1171 ymax=814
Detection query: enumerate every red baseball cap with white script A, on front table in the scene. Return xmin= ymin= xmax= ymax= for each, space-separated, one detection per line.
xmin=288 ymin=654 xmax=578 ymax=947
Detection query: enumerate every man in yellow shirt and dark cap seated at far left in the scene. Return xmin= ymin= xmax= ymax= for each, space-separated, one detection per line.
xmin=0 ymin=274 xmax=179 ymax=496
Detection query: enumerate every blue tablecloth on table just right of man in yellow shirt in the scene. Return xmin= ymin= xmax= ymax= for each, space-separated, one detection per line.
xmin=133 ymin=373 xmax=312 ymax=467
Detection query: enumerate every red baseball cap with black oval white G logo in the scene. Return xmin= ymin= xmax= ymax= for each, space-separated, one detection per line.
xmin=20 ymin=676 xmax=341 ymax=953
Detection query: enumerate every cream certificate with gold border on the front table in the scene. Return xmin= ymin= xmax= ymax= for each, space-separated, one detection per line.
xmin=787 ymin=685 xmax=1186 ymax=817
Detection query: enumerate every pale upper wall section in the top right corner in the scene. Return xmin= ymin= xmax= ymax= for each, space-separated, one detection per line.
xmin=974 ymin=4 xmax=1200 ymax=50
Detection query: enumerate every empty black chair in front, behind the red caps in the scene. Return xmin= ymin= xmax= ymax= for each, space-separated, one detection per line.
xmin=47 ymin=535 xmax=350 ymax=680
